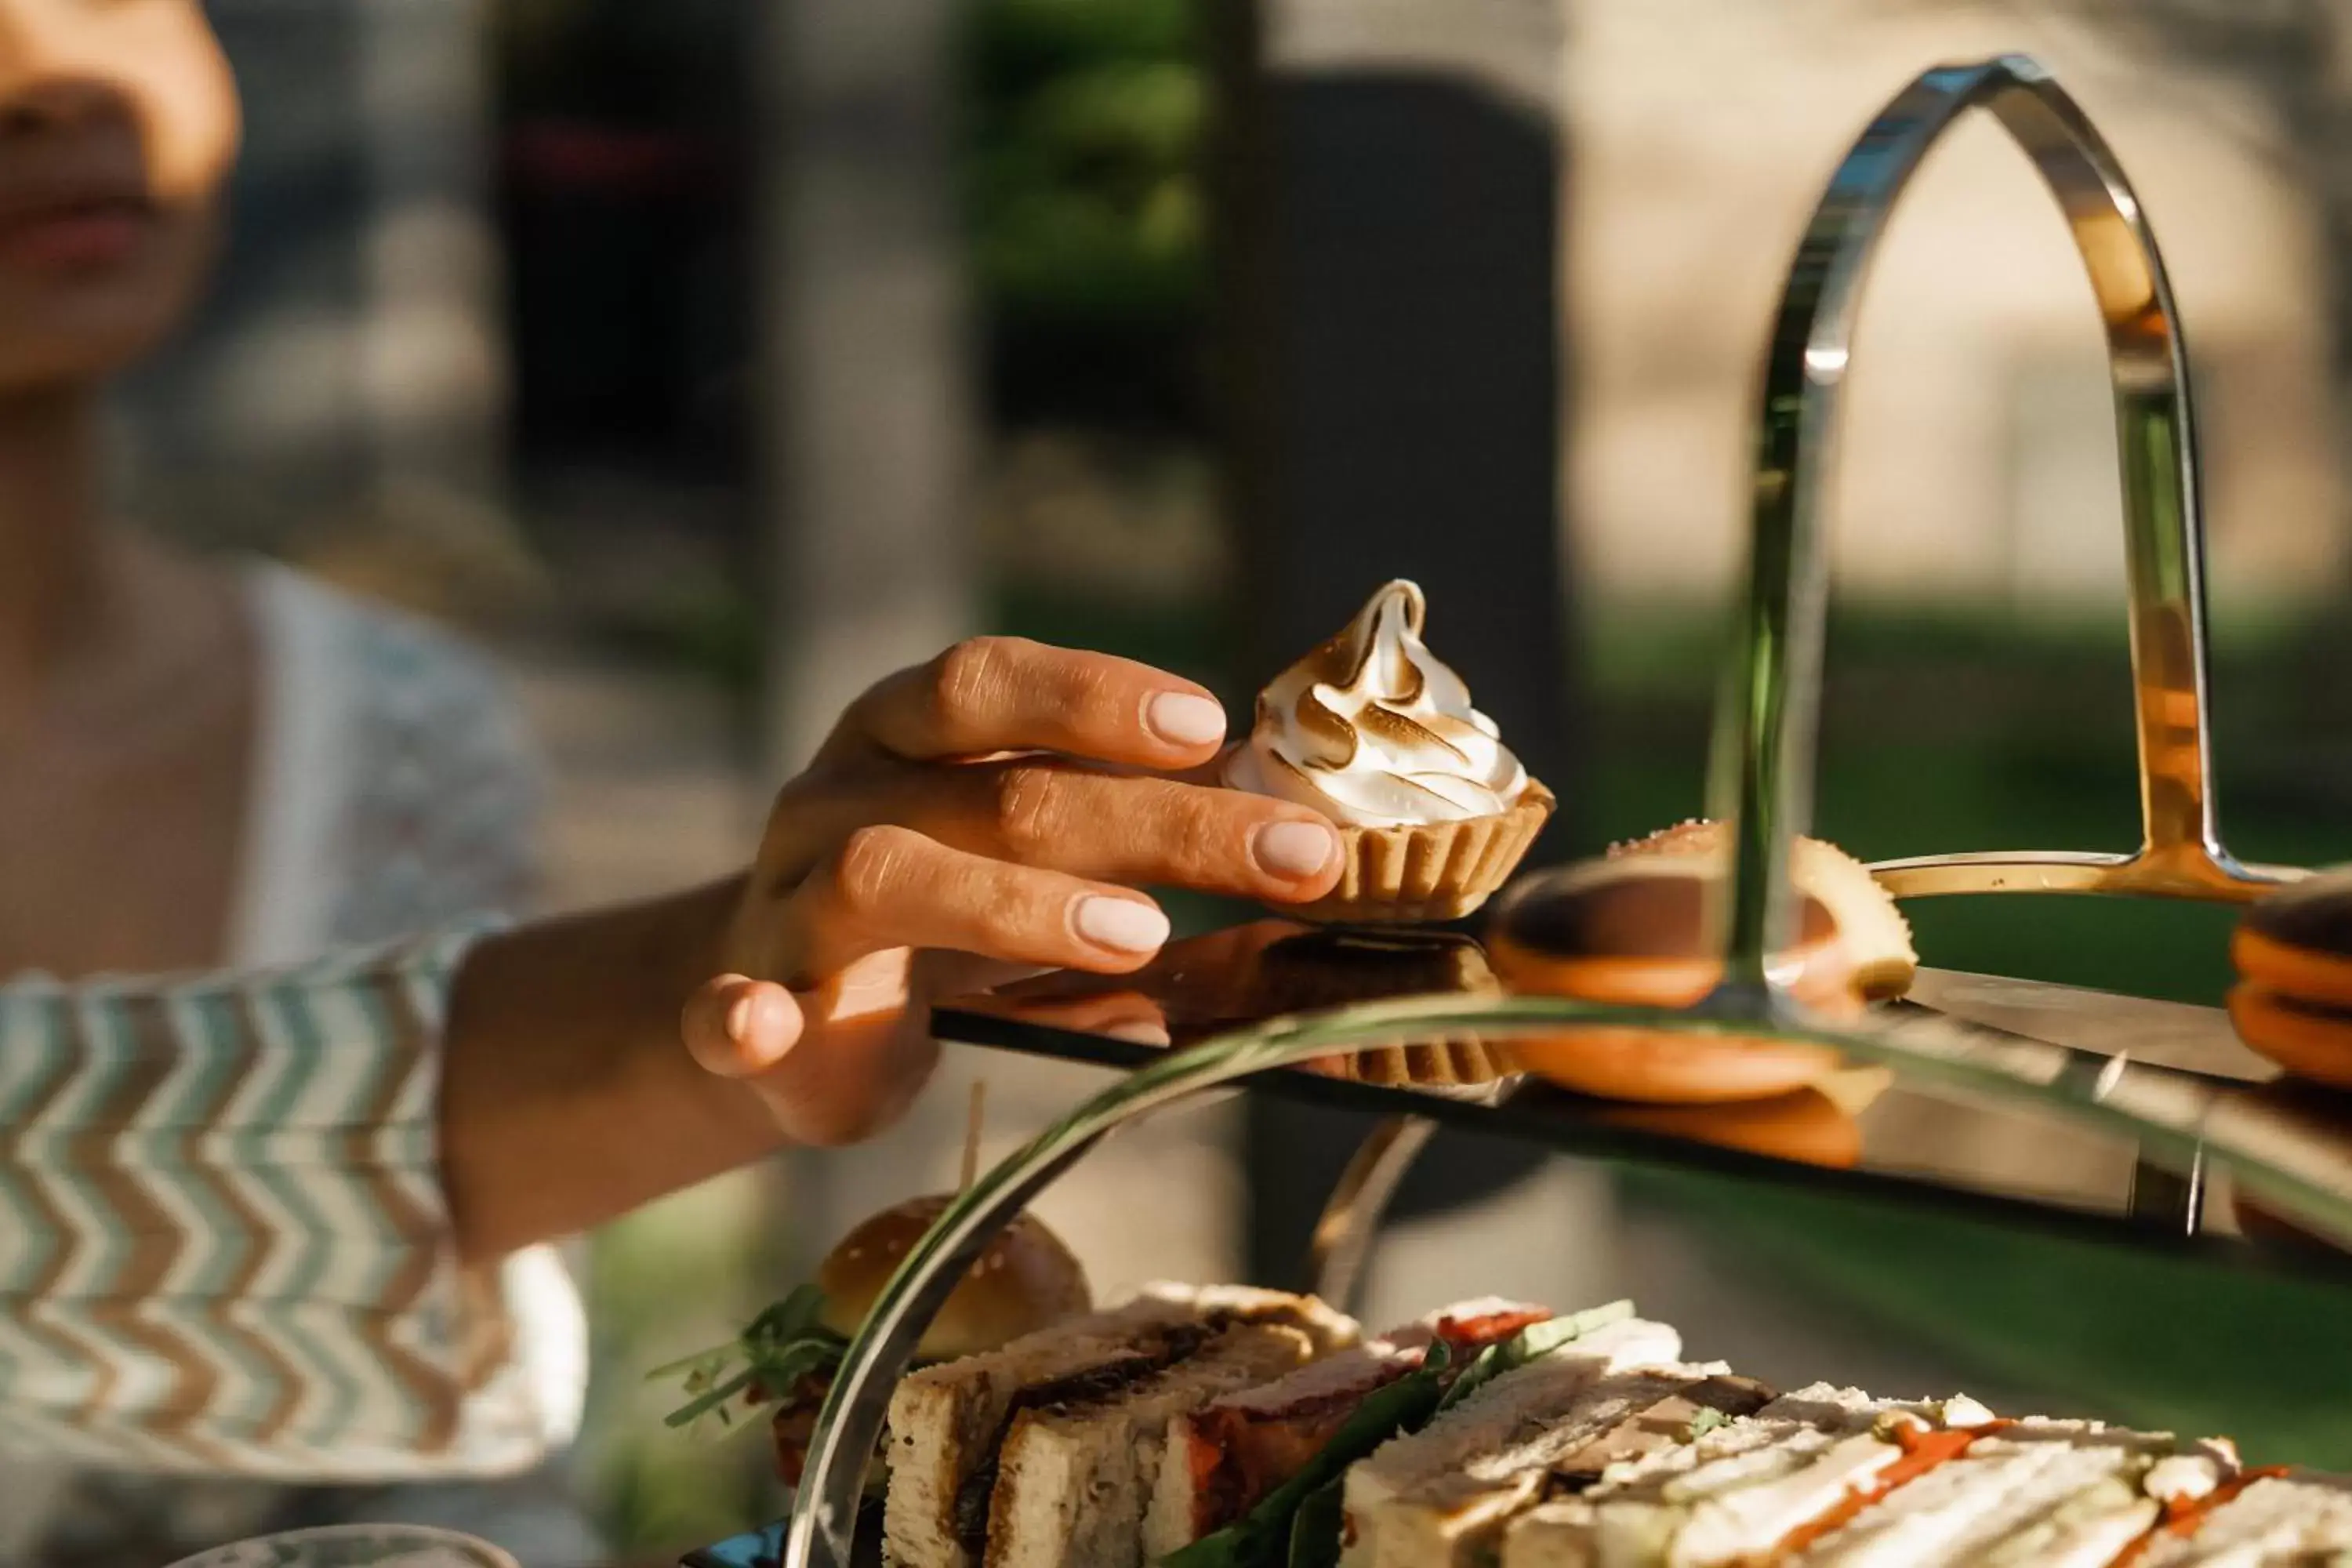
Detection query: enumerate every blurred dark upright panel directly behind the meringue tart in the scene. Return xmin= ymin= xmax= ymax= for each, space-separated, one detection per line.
xmin=1216 ymin=0 xmax=1583 ymax=1279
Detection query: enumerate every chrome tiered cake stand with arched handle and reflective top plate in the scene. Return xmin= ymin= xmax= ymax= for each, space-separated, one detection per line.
xmin=689 ymin=56 xmax=2352 ymax=1568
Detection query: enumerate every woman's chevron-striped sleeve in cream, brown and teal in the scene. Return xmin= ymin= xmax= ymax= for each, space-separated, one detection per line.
xmin=0 ymin=928 xmax=576 ymax=1481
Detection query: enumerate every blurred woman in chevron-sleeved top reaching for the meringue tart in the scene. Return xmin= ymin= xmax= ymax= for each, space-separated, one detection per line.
xmin=0 ymin=0 xmax=1338 ymax=1568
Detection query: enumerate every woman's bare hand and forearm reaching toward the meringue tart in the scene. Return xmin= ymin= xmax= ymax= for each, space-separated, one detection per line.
xmin=442 ymin=640 xmax=1338 ymax=1258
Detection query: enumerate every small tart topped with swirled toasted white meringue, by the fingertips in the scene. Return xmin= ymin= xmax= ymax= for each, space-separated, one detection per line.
xmin=1225 ymin=581 xmax=1555 ymax=921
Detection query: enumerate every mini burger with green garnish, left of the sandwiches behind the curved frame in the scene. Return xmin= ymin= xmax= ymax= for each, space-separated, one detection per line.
xmin=652 ymin=1194 xmax=1094 ymax=1486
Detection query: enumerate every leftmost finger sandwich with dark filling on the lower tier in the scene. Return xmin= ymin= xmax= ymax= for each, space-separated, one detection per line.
xmin=882 ymin=1286 xmax=1357 ymax=1568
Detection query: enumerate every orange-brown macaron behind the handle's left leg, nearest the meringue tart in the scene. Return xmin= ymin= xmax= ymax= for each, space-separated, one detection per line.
xmin=1489 ymin=822 xmax=1919 ymax=1105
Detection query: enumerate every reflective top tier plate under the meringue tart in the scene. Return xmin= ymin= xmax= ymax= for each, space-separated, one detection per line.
xmin=934 ymin=919 xmax=2352 ymax=1283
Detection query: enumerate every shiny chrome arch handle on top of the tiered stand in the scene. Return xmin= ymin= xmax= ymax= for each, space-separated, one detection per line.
xmin=1712 ymin=54 xmax=2300 ymax=996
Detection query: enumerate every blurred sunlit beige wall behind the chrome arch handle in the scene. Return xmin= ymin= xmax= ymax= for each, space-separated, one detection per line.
xmin=1566 ymin=0 xmax=2347 ymax=614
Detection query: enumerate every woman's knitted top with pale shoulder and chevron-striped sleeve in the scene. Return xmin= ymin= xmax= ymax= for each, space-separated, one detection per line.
xmin=0 ymin=567 xmax=595 ymax=1568
